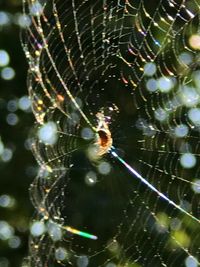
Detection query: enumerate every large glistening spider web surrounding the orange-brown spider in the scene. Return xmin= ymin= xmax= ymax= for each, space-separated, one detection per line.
xmin=23 ymin=0 xmax=200 ymax=267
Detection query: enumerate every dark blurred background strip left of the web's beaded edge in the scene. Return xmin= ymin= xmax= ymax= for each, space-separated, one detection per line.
xmin=0 ymin=0 xmax=37 ymax=267
